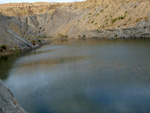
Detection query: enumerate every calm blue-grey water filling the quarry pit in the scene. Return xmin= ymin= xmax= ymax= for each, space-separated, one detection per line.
xmin=0 ymin=40 xmax=150 ymax=113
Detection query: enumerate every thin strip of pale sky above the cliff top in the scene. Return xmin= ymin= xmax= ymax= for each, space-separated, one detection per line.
xmin=0 ymin=0 xmax=83 ymax=3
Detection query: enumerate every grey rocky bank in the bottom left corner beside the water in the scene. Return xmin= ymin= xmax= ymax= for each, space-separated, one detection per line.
xmin=0 ymin=80 xmax=27 ymax=113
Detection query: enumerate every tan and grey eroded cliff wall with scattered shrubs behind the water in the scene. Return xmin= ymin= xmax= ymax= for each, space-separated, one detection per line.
xmin=0 ymin=0 xmax=150 ymax=48
